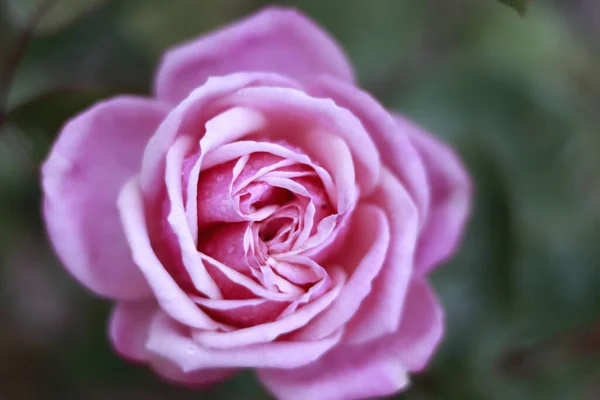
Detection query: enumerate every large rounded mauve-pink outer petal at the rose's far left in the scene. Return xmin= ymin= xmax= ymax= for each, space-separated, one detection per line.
xmin=42 ymin=97 xmax=168 ymax=299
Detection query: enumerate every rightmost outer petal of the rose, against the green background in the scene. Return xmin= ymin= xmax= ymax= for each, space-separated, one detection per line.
xmin=395 ymin=116 xmax=472 ymax=273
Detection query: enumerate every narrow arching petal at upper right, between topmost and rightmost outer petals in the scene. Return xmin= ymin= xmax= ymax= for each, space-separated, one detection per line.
xmin=308 ymin=76 xmax=430 ymax=225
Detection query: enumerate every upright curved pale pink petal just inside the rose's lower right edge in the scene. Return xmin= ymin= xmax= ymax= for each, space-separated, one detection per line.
xmin=345 ymin=168 xmax=419 ymax=343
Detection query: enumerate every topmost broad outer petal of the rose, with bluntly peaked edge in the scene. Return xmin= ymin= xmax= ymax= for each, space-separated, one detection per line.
xmin=155 ymin=7 xmax=354 ymax=103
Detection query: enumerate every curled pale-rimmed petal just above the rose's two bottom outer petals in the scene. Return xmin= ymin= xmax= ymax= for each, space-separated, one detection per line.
xmin=147 ymin=313 xmax=342 ymax=373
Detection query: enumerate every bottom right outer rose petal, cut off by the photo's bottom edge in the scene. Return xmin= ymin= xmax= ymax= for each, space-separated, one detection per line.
xmin=258 ymin=278 xmax=443 ymax=400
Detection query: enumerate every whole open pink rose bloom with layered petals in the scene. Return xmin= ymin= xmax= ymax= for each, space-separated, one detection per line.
xmin=42 ymin=8 xmax=470 ymax=400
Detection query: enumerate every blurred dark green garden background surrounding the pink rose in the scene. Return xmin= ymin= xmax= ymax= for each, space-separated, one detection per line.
xmin=0 ymin=0 xmax=600 ymax=400
